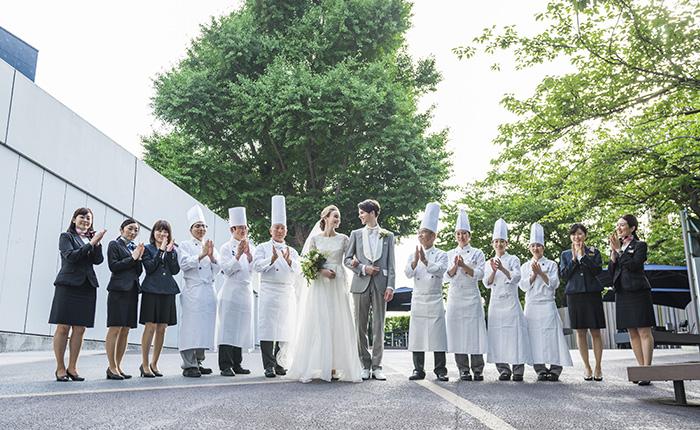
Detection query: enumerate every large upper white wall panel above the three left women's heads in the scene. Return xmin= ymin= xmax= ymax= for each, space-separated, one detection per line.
xmin=7 ymin=73 xmax=136 ymax=213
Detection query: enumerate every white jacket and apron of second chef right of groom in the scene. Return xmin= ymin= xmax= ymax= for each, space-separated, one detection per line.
xmin=444 ymin=245 xmax=488 ymax=354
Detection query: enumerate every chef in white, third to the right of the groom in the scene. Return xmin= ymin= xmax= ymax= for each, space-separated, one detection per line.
xmin=483 ymin=219 xmax=532 ymax=381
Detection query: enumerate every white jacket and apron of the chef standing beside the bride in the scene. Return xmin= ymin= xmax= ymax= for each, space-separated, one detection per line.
xmin=253 ymin=241 xmax=301 ymax=341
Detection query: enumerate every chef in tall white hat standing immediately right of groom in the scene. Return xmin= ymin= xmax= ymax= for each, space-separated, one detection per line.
xmin=404 ymin=203 xmax=448 ymax=381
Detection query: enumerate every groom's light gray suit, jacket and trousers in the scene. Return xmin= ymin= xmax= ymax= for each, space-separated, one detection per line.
xmin=345 ymin=228 xmax=396 ymax=370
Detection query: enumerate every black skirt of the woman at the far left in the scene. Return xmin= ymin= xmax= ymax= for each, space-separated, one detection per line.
xmin=49 ymin=281 xmax=97 ymax=327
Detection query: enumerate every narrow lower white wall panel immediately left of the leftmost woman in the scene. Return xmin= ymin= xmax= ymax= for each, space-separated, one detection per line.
xmin=25 ymin=171 xmax=66 ymax=334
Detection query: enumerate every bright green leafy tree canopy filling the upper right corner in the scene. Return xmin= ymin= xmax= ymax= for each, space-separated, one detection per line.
xmin=455 ymin=0 xmax=700 ymax=264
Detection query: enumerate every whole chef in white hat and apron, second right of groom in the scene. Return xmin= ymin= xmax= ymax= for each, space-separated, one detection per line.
xmin=444 ymin=209 xmax=488 ymax=381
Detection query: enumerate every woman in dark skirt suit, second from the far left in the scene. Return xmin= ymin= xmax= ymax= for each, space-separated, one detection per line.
xmin=105 ymin=218 xmax=144 ymax=380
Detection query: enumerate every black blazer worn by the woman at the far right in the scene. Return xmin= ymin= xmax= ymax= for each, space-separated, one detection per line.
xmin=608 ymin=239 xmax=651 ymax=292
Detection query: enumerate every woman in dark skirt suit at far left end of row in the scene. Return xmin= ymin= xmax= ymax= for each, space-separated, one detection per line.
xmin=49 ymin=208 xmax=106 ymax=382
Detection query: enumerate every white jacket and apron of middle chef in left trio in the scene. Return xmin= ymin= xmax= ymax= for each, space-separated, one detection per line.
xmin=216 ymin=238 xmax=257 ymax=350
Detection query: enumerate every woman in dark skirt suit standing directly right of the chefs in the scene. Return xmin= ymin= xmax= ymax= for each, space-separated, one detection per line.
xmin=559 ymin=223 xmax=605 ymax=381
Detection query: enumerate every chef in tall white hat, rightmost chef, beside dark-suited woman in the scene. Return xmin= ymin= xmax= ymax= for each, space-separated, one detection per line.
xmin=520 ymin=223 xmax=573 ymax=381
